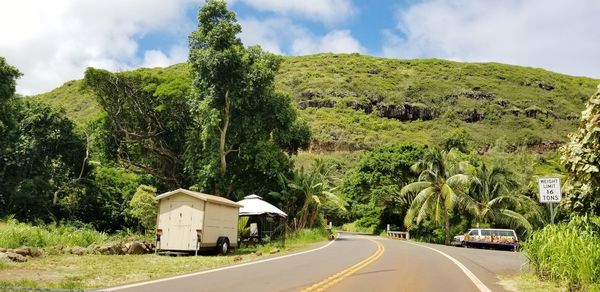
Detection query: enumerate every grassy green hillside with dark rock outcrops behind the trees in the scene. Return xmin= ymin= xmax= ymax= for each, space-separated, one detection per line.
xmin=37 ymin=54 xmax=600 ymax=151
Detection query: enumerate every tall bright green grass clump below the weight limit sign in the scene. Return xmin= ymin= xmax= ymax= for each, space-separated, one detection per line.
xmin=524 ymin=217 xmax=600 ymax=291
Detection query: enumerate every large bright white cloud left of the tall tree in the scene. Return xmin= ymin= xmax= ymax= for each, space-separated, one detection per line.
xmin=0 ymin=0 xmax=199 ymax=94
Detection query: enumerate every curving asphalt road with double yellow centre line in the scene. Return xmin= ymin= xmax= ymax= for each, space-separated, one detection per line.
xmin=103 ymin=233 xmax=525 ymax=292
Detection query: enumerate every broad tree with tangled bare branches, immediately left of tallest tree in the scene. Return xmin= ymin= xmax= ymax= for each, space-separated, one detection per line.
xmin=84 ymin=68 xmax=190 ymax=186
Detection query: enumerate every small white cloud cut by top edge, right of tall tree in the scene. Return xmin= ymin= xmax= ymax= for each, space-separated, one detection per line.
xmin=236 ymin=0 xmax=355 ymax=23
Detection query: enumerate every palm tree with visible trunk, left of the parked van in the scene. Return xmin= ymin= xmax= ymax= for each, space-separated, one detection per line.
xmin=400 ymin=148 xmax=470 ymax=244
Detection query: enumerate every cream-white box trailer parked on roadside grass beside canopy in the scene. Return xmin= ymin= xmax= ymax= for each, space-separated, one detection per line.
xmin=156 ymin=189 xmax=242 ymax=254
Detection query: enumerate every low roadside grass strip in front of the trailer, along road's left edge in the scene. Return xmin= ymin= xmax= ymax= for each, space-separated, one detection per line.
xmin=0 ymin=229 xmax=327 ymax=289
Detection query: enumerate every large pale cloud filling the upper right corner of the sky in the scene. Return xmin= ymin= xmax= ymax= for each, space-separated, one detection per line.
xmin=382 ymin=0 xmax=600 ymax=77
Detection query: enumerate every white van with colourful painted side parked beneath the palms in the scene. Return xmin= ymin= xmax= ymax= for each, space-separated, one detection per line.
xmin=452 ymin=228 xmax=519 ymax=250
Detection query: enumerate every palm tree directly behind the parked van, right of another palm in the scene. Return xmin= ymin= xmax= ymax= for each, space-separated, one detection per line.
xmin=461 ymin=163 xmax=538 ymax=231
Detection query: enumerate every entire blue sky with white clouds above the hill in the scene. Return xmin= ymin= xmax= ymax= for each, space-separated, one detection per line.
xmin=0 ymin=0 xmax=600 ymax=95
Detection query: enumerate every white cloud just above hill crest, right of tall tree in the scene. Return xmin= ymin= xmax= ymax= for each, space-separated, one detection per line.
xmin=240 ymin=18 xmax=366 ymax=55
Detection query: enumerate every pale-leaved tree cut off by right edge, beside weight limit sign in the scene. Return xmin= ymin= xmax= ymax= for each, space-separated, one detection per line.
xmin=561 ymin=86 xmax=600 ymax=215
